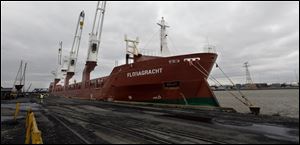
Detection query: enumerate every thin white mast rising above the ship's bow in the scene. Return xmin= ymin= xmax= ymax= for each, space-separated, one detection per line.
xmin=157 ymin=17 xmax=170 ymax=55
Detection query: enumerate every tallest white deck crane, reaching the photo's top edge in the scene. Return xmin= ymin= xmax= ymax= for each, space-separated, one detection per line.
xmin=82 ymin=1 xmax=106 ymax=88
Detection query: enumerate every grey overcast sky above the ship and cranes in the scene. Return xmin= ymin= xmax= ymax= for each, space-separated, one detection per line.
xmin=1 ymin=1 xmax=299 ymax=88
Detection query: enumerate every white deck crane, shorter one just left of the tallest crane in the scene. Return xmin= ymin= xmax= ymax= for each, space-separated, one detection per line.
xmin=64 ymin=11 xmax=85 ymax=87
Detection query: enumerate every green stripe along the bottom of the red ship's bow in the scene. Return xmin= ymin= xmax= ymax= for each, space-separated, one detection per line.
xmin=147 ymin=98 xmax=218 ymax=106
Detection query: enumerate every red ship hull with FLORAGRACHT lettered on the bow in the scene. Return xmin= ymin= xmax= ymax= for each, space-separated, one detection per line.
xmin=49 ymin=53 xmax=219 ymax=106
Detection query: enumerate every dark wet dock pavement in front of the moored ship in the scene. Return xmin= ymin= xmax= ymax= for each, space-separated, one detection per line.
xmin=1 ymin=96 xmax=299 ymax=144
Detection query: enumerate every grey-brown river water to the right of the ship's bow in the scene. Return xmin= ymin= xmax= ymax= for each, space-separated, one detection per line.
xmin=214 ymin=89 xmax=299 ymax=118
